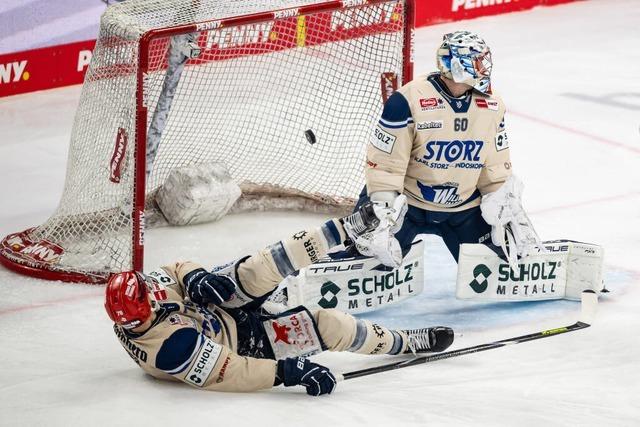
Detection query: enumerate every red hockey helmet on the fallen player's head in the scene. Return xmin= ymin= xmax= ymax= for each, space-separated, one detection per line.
xmin=104 ymin=271 xmax=151 ymax=329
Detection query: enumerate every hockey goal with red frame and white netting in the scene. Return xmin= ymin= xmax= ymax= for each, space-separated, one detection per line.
xmin=0 ymin=0 xmax=413 ymax=283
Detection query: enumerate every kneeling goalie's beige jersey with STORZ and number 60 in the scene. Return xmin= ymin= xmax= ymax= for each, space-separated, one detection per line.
xmin=366 ymin=73 xmax=511 ymax=211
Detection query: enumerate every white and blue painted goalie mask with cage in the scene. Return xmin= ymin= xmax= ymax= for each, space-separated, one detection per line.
xmin=436 ymin=31 xmax=493 ymax=95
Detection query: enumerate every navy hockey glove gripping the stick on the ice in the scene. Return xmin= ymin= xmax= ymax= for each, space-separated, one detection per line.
xmin=276 ymin=356 xmax=336 ymax=396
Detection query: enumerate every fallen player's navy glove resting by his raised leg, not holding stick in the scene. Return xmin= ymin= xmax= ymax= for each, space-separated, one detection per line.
xmin=183 ymin=268 xmax=236 ymax=305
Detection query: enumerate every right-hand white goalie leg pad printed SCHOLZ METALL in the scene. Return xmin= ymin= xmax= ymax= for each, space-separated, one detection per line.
xmin=456 ymin=240 xmax=604 ymax=302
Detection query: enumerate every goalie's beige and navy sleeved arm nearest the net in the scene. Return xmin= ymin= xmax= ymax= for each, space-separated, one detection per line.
xmin=365 ymin=92 xmax=414 ymax=196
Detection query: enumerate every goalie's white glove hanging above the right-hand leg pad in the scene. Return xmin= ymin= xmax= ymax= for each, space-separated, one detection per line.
xmin=480 ymin=175 xmax=547 ymax=268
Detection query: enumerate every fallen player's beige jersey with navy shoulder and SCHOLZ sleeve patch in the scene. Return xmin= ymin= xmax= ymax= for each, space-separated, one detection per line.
xmin=114 ymin=263 xmax=276 ymax=391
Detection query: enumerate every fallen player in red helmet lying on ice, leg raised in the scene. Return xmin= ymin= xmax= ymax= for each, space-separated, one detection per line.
xmin=105 ymin=203 xmax=453 ymax=396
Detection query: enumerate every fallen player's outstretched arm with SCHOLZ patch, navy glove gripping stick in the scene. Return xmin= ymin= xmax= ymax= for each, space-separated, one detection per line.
xmin=155 ymin=328 xmax=336 ymax=396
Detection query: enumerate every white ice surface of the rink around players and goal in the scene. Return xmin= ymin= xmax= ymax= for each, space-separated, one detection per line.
xmin=0 ymin=0 xmax=640 ymax=427
